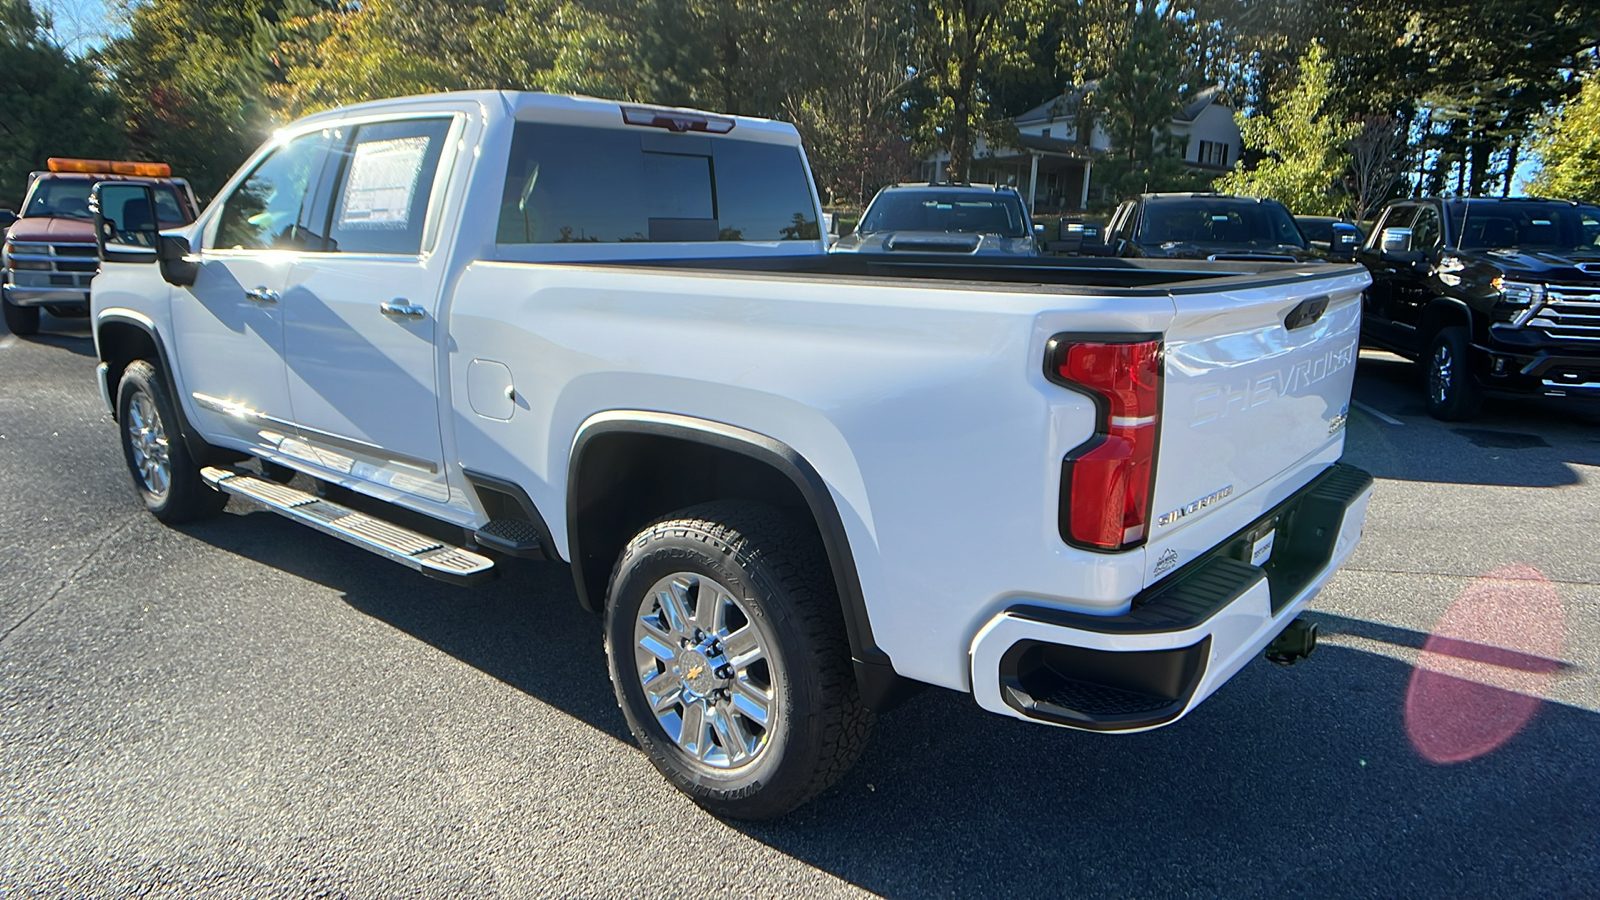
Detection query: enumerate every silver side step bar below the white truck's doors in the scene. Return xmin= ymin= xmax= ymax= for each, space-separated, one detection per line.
xmin=200 ymin=466 xmax=494 ymax=585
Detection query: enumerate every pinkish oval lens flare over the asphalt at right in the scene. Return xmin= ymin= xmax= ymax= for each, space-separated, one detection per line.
xmin=1405 ymin=565 xmax=1566 ymax=764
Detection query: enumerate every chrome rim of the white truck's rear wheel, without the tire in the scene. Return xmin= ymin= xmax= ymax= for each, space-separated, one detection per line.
xmin=634 ymin=572 xmax=781 ymax=770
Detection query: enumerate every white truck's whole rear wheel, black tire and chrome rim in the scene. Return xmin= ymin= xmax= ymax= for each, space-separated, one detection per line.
xmin=605 ymin=501 xmax=872 ymax=820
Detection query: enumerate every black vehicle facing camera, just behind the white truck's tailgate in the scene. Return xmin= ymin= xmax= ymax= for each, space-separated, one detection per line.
xmin=1106 ymin=194 xmax=1315 ymax=263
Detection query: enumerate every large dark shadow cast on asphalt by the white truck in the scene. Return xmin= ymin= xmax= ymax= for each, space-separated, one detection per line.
xmin=186 ymin=514 xmax=1600 ymax=897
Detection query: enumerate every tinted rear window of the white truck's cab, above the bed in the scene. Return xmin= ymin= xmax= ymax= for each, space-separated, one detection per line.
xmin=496 ymin=122 xmax=822 ymax=243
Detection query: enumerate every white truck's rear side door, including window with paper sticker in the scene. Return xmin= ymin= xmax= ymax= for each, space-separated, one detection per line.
xmin=283 ymin=117 xmax=453 ymax=503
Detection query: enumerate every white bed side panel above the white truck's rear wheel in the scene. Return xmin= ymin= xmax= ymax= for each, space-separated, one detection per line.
xmin=448 ymin=263 xmax=1173 ymax=689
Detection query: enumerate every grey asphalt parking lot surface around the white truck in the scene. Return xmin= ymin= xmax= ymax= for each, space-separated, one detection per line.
xmin=0 ymin=320 xmax=1600 ymax=897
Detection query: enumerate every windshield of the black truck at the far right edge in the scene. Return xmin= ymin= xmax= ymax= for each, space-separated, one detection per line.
xmin=1448 ymin=200 xmax=1600 ymax=253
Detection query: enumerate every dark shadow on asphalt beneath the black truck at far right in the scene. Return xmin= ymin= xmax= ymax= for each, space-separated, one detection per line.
xmin=1344 ymin=354 xmax=1600 ymax=487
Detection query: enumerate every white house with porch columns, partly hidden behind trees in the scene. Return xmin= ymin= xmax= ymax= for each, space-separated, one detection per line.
xmin=922 ymin=82 xmax=1243 ymax=211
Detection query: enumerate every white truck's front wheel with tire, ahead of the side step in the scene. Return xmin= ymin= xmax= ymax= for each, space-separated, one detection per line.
xmin=117 ymin=360 xmax=227 ymax=525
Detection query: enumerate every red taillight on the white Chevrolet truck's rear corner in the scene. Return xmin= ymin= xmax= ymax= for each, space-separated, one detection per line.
xmin=1046 ymin=338 xmax=1162 ymax=549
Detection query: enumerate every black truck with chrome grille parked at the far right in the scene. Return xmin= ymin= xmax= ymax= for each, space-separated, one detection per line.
xmin=1358 ymin=197 xmax=1600 ymax=421
